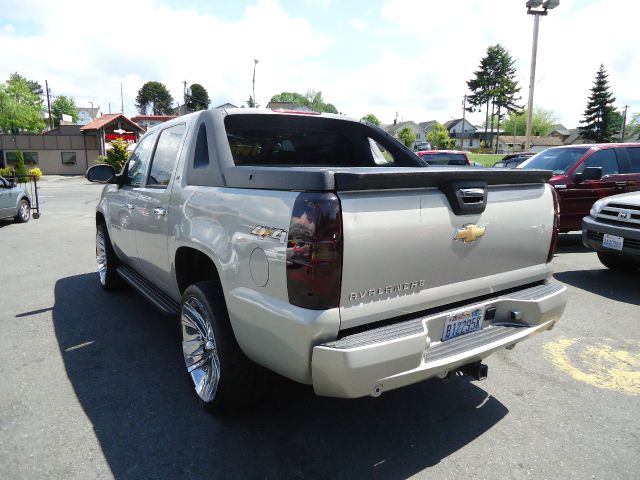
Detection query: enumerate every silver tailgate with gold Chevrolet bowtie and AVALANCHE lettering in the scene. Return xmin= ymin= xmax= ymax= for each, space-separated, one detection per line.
xmin=338 ymin=183 xmax=553 ymax=329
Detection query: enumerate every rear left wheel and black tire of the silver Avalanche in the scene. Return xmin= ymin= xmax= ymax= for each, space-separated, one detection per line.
xmin=180 ymin=281 xmax=265 ymax=413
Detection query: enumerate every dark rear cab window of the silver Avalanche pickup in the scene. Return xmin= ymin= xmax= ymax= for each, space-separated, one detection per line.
xmin=225 ymin=114 xmax=420 ymax=167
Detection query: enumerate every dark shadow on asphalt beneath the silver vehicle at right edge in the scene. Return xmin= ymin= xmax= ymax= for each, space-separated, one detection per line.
xmin=553 ymin=265 xmax=640 ymax=305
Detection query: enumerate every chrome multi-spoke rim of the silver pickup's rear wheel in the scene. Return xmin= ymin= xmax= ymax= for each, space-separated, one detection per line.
xmin=181 ymin=296 xmax=220 ymax=403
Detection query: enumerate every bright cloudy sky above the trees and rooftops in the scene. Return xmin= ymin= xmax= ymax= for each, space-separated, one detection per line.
xmin=0 ymin=0 xmax=640 ymax=128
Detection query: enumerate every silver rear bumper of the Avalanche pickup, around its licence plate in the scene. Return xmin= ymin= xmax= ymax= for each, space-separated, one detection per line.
xmin=312 ymin=283 xmax=567 ymax=398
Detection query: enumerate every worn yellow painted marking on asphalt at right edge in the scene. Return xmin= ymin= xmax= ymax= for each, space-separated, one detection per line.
xmin=544 ymin=338 xmax=640 ymax=395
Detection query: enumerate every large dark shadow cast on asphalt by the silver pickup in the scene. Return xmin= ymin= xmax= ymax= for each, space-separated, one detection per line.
xmin=53 ymin=274 xmax=508 ymax=479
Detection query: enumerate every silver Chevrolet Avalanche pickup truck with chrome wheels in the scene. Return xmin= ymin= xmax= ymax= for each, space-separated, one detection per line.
xmin=87 ymin=109 xmax=567 ymax=411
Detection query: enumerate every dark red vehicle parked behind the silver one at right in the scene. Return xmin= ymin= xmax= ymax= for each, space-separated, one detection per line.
xmin=517 ymin=143 xmax=640 ymax=232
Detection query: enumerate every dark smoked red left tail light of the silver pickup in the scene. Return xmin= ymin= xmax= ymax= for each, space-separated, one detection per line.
xmin=287 ymin=193 xmax=342 ymax=310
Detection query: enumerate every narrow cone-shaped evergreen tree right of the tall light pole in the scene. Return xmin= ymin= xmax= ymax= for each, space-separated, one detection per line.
xmin=580 ymin=64 xmax=620 ymax=143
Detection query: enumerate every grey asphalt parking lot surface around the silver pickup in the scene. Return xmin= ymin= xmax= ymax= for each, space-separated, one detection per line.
xmin=0 ymin=177 xmax=640 ymax=479
